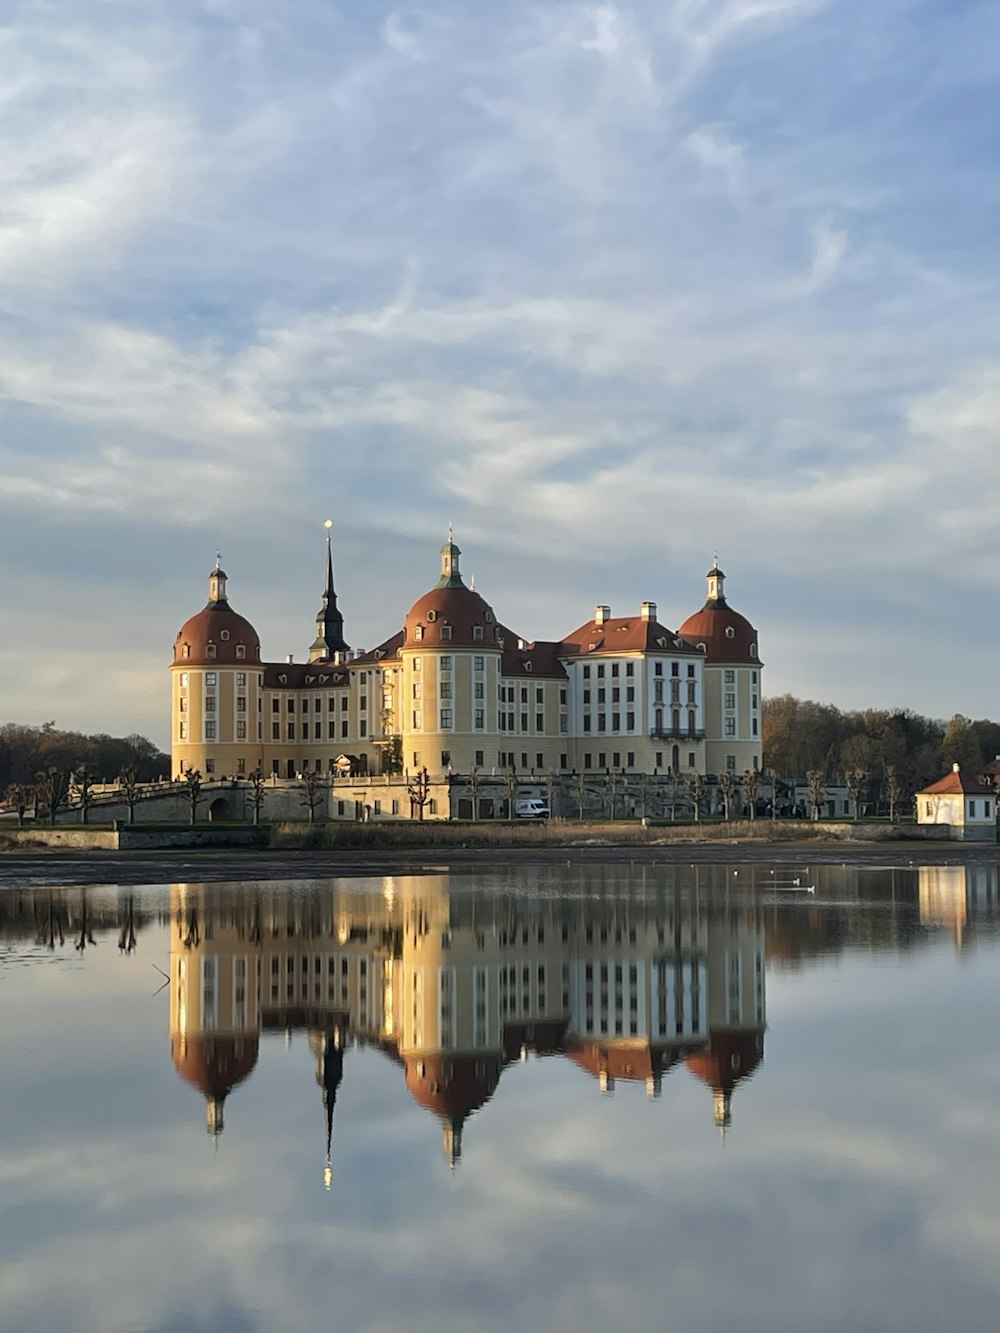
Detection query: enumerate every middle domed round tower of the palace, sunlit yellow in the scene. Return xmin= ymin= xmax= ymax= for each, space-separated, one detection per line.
xmin=399 ymin=533 xmax=503 ymax=778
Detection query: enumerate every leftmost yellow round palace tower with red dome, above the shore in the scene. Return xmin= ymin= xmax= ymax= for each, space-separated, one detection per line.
xmin=171 ymin=559 xmax=264 ymax=778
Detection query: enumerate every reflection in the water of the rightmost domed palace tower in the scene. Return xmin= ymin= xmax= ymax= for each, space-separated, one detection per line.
xmin=687 ymin=898 xmax=764 ymax=1134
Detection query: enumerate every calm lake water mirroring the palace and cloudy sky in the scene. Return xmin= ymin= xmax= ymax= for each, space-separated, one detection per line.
xmin=0 ymin=862 xmax=1000 ymax=1333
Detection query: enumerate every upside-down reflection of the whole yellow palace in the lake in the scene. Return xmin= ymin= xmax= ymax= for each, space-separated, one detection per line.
xmin=169 ymin=876 xmax=764 ymax=1162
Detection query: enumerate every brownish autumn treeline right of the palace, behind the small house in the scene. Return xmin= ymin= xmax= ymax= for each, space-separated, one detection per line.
xmin=763 ymin=694 xmax=1000 ymax=793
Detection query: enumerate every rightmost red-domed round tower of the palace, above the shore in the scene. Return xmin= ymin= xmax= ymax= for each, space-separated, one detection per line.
xmin=677 ymin=560 xmax=764 ymax=774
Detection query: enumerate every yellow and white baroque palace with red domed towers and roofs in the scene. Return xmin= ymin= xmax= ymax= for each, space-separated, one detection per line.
xmin=171 ymin=535 xmax=761 ymax=817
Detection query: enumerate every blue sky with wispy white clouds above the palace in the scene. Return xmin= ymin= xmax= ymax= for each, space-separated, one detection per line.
xmin=0 ymin=0 xmax=1000 ymax=742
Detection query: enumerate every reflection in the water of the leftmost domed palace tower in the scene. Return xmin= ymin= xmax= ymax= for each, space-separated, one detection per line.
xmin=169 ymin=886 xmax=260 ymax=1136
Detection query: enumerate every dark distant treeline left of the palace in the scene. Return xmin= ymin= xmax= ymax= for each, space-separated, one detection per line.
xmin=0 ymin=722 xmax=171 ymax=792
